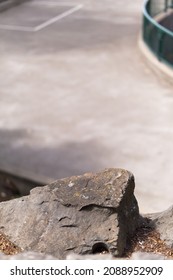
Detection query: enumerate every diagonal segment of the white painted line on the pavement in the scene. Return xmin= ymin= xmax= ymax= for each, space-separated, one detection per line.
xmin=34 ymin=5 xmax=83 ymax=32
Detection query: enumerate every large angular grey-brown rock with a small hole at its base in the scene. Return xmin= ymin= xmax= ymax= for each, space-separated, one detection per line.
xmin=0 ymin=169 xmax=140 ymax=259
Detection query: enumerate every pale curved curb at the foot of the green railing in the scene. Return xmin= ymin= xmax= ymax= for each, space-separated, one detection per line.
xmin=138 ymin=34 xmax=173 ymax=85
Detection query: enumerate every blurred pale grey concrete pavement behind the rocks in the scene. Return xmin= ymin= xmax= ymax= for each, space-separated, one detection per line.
xmin=0 ymin=0 xmax=173 ymax=213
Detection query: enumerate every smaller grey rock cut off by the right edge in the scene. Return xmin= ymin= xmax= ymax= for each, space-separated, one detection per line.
xmin=146 ymin=206 xmax=173 ymax=249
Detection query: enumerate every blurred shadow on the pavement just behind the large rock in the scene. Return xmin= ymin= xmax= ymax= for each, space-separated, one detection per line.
xmin=0 ymin=130 xmax=111 ymax=179
